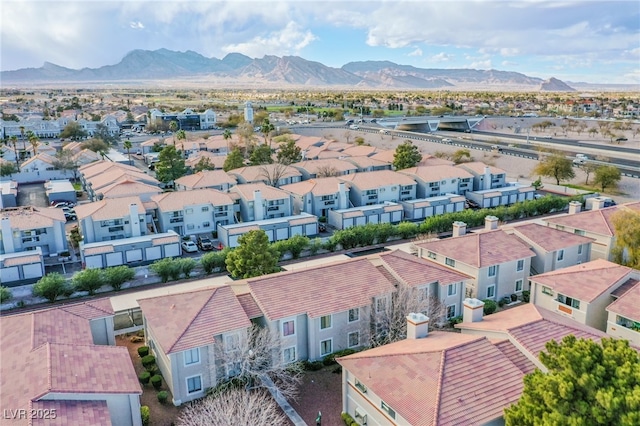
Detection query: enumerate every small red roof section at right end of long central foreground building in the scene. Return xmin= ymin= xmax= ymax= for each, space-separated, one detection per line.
xmin=380 ymin=250 xmax=471 ymax=287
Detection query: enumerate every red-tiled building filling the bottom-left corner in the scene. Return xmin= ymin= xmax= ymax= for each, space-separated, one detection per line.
xmin=0 ymin=299 xmax=142 ymax=426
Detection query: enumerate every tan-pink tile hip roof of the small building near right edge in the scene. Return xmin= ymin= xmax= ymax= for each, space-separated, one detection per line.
xmin=530 ymin=259 xmax=632 ymax=303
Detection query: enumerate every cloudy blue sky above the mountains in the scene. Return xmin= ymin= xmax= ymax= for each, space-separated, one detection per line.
xmin=0 ymin=0 xmax=640 ymax=84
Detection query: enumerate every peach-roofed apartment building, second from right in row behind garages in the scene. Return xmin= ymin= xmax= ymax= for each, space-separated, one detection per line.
xmin=398 ymin=165 xmax=473 ymax=198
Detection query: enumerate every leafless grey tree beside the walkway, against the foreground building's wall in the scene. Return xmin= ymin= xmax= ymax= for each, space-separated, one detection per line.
xmin=214 ymin=325 xmax=302 ymax=402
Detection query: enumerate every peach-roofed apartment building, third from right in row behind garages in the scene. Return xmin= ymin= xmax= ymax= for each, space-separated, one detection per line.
xmin=338 ymin=170 xmax=417 ymax=207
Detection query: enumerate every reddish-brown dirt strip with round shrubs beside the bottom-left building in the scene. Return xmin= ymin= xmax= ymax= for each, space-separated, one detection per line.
xmin=116 ymin=335 xmax=180 ymax=426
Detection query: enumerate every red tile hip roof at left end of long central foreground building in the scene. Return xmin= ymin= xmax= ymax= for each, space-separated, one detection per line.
xmin=138 ymin=286 xmax=251 ymax=354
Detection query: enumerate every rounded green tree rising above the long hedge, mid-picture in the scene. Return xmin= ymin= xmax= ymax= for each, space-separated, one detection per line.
xmin=225 ymin=229 xmax=280 ymax=278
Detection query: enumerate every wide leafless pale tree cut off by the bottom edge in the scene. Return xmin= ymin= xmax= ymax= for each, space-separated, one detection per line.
xmin=178 ymin=389 xmax=288 ymax=426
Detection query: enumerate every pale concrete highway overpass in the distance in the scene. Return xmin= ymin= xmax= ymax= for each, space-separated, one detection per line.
xmin=377 ymin=116 xmax=484 ymax=132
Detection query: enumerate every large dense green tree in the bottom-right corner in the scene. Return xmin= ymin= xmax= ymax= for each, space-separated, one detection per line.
xmin=505 ymin=335 xmax=640 ymax=426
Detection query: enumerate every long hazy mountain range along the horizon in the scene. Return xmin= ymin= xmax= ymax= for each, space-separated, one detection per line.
xmin=0 ymin=49 xmax=575 ymax=92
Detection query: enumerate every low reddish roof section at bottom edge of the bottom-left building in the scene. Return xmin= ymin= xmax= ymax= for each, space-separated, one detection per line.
xmin=29 ymin=400 xmax=112 ymax=426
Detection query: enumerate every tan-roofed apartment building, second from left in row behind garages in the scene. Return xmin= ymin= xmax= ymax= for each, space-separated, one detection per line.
xmin=74 ymin=196 xmax=147 ymax=244
